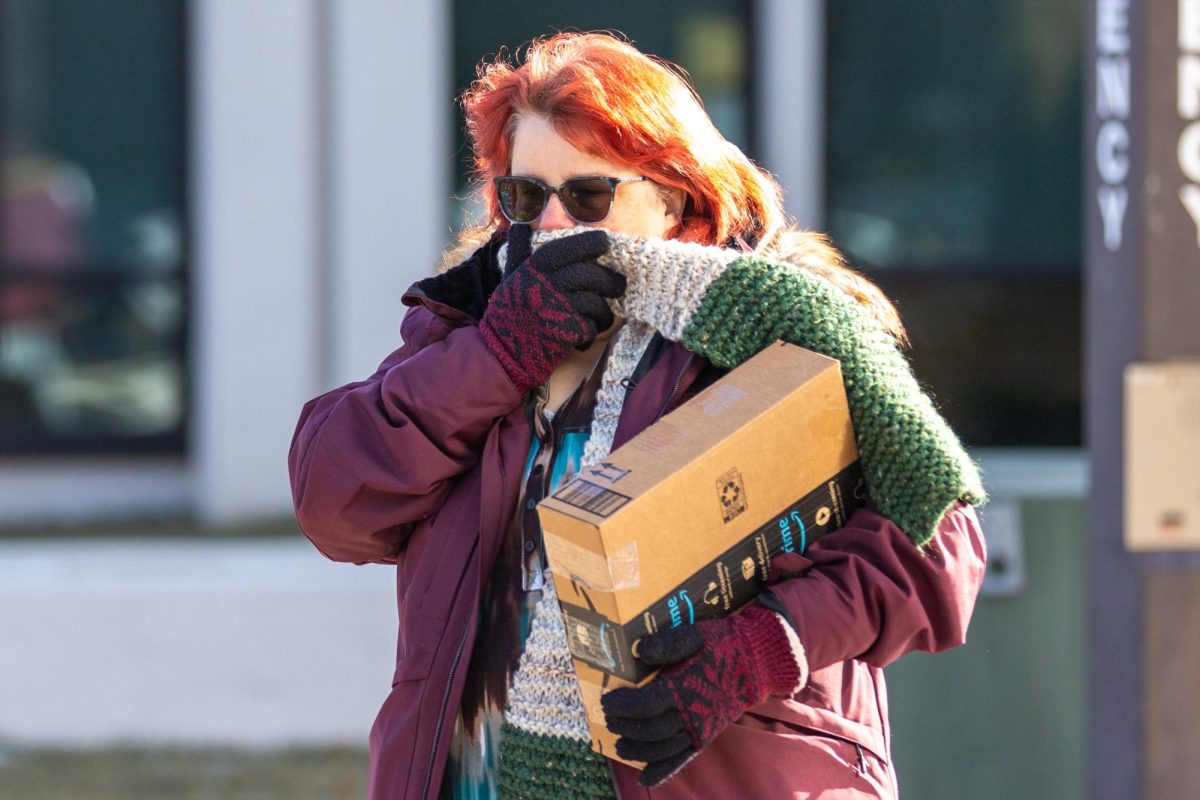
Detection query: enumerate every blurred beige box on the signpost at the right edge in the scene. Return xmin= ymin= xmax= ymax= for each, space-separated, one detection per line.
xmin=1124 ymin=360 xmax=1200 ymax=551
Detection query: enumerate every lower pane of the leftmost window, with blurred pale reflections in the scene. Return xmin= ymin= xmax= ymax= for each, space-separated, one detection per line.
xmin=0 ymin=273 xmax=184 ymax=451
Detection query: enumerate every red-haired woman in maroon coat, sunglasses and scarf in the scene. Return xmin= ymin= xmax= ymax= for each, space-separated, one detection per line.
xmin=289 ymin=34 xmax=984 ymax=800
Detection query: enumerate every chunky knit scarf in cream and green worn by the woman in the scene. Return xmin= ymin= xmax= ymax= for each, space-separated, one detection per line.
xmin=499 ymin=230 xmax=986 ymax=800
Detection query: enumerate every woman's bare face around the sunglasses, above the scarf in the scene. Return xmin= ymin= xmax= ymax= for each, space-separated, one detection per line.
xmin=511 ymin=115 xmax=683 ymax=239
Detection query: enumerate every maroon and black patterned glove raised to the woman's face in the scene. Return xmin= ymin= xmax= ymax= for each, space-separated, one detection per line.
xmin=479 ymin=224 xmax=625 ymax=392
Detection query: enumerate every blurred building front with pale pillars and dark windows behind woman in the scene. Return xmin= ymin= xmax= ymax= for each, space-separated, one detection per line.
xmin=0 ymin=0 xmax=1087 ymax=798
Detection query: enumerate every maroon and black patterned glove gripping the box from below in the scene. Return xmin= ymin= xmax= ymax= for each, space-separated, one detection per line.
xmin=600 ymin=604 xmax=808 ymax=787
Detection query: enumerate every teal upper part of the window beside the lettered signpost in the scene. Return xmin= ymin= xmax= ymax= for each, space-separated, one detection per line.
xmin=827 ymin=0 xmax=1082 ymax=271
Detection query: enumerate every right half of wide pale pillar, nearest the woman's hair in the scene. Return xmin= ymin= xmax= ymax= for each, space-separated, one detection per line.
xmin=320 ymin=0 xmax=455 ymax=386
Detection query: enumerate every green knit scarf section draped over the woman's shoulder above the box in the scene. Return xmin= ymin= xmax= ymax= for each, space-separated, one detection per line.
xmin=683 ymin=255 xmax=986 ymax=545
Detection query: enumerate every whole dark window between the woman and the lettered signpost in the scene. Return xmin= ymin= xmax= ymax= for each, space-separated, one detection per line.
xmin=826 ymin=0 xmax=1082 ymax=446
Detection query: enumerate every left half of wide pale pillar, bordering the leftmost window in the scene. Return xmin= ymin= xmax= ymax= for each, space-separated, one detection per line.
xmin=188 ymin=0 xmax=325 ymax=523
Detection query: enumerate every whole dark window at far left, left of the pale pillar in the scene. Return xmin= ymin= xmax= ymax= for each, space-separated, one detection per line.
xmin=0 ymin=0 xmax=186 ymax=453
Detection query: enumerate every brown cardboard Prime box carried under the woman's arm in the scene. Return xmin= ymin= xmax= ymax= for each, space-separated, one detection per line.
xmin=539 ymin=342 xmax=864 ymax=757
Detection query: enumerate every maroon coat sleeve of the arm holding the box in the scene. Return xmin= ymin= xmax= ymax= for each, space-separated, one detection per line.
xmin=770 ymin=500 xmax=986 ymax=672
